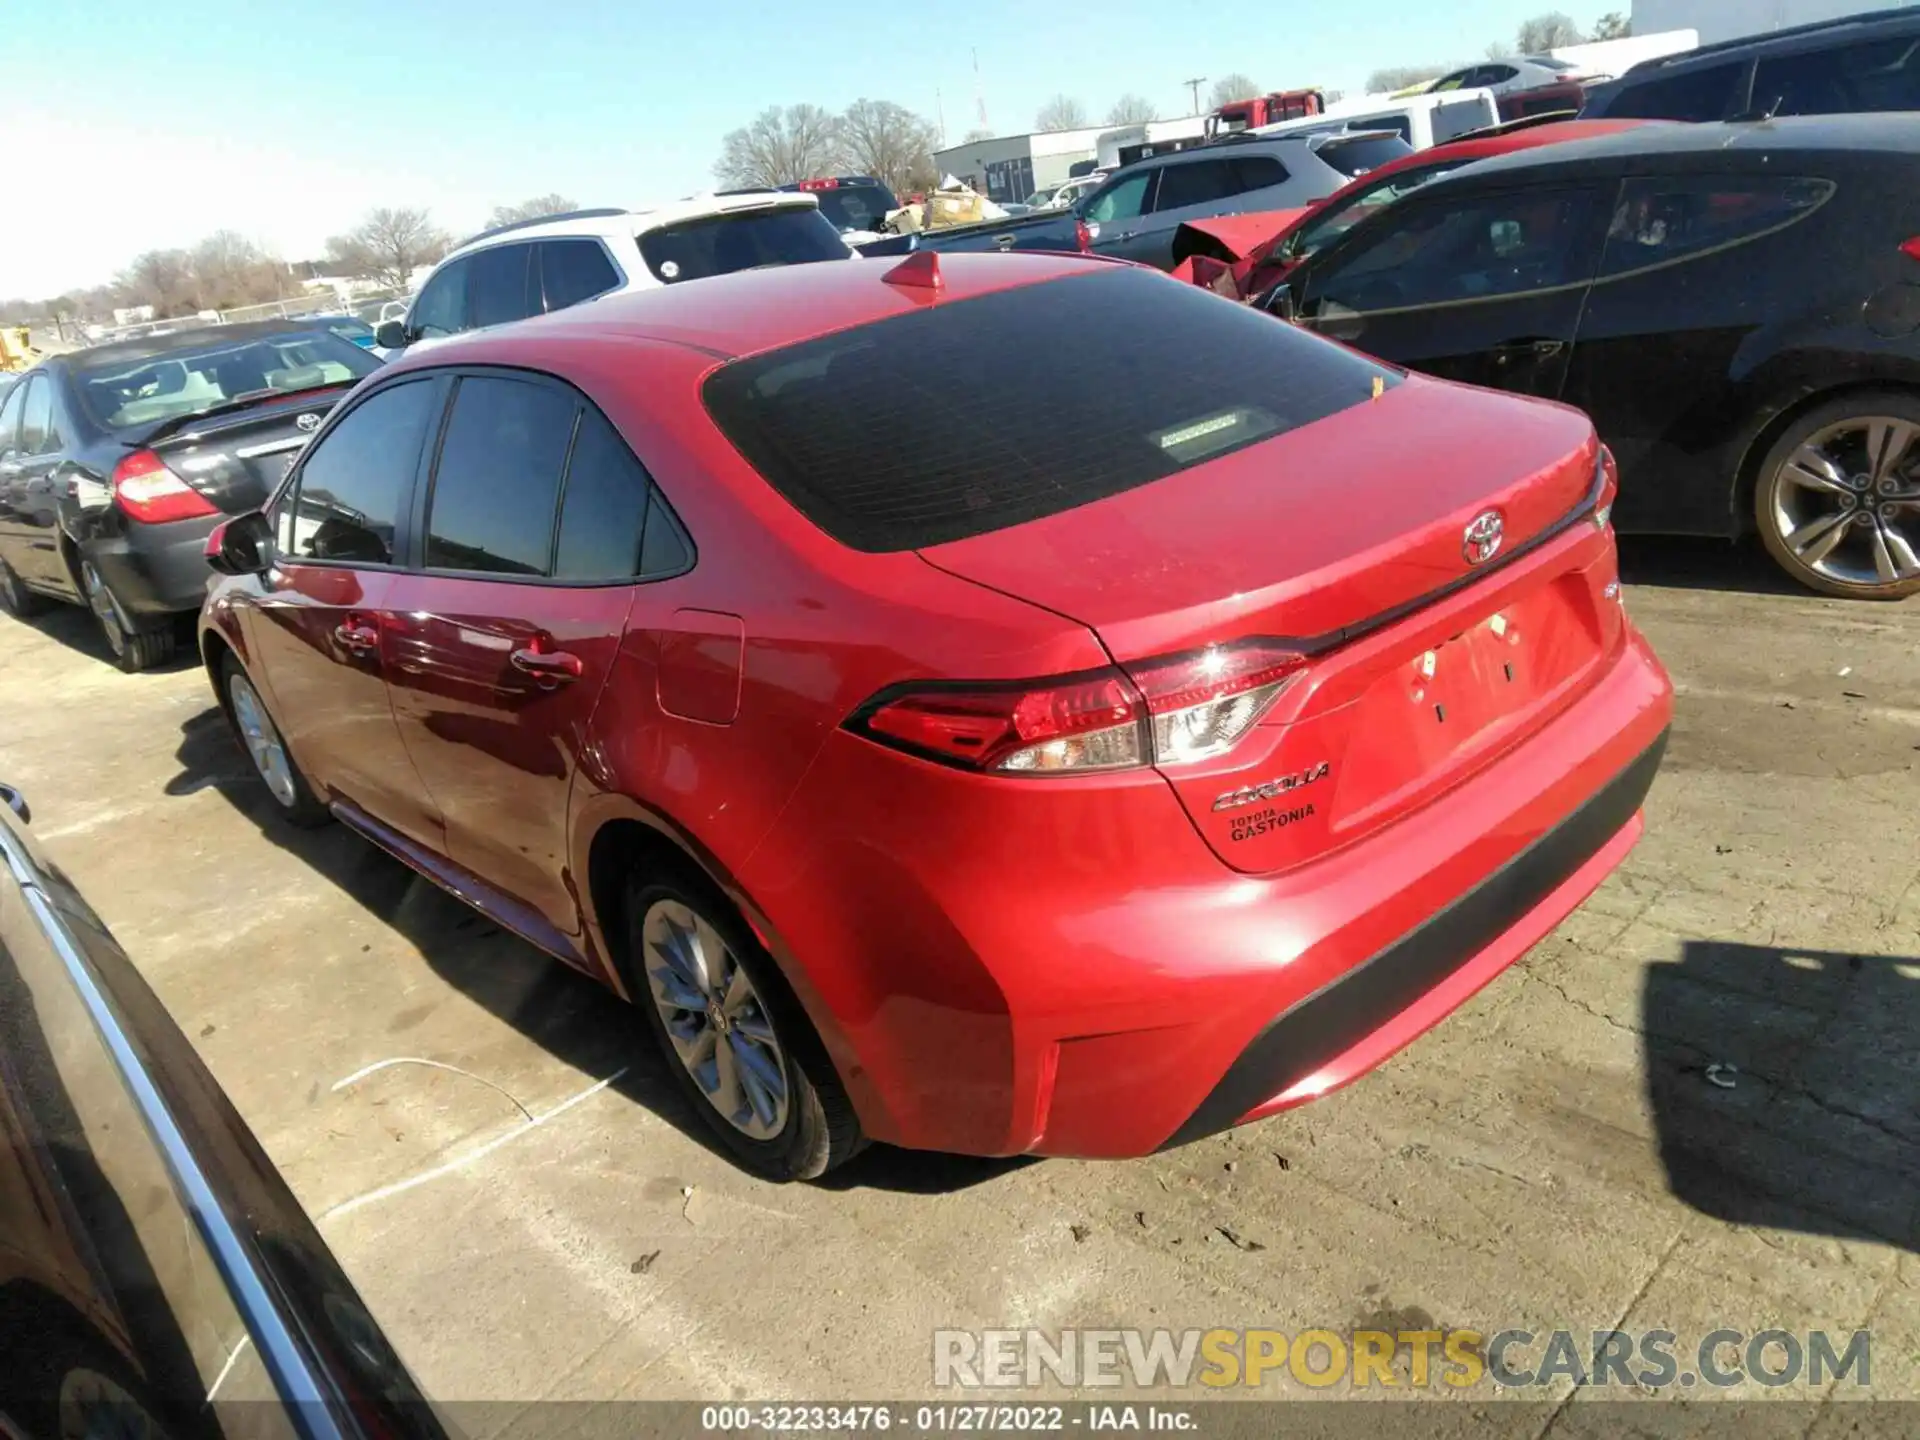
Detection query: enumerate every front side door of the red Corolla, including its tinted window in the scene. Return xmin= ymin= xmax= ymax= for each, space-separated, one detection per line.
xmin=242 ymin=374 xmax=445 ymax=852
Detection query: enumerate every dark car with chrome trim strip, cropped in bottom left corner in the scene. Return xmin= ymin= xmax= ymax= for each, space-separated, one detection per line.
xmin=0 ymin=785 xmax=445 ymax=1440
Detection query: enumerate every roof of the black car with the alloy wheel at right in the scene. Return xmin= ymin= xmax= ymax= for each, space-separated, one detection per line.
xmin=1450 ymin=111 xmax=1920 ymax=179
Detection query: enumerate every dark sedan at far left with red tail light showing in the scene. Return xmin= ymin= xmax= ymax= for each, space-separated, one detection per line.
xmin=0 ymin=321 xmax=380 ymax=670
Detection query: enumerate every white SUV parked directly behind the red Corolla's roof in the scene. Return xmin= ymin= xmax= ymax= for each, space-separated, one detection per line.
xmin=376 ymin=190 xmax=854 ymax=351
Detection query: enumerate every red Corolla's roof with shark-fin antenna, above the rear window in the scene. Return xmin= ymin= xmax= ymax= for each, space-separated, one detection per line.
xmin=388 ymin=252 xmax=1121 ymax=371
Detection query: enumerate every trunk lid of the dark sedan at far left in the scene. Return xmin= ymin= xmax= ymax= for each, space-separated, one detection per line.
xmin=134 ymin=384 xmax=351 ymax=515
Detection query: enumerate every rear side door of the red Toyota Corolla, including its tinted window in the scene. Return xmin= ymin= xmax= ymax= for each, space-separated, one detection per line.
xmin=384 ymin=371 xmax=649 ymax=954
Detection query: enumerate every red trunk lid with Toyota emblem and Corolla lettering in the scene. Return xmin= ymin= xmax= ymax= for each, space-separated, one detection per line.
xmin=920 ymin=376 xmax=1620 ymax=872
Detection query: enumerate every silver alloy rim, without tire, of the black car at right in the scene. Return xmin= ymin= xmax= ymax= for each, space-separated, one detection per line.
xmin=1768 ymin=415 xmax=1920 ymax=589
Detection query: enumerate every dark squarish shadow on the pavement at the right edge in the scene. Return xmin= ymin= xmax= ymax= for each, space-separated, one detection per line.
xmin=1644 ymin=941 xmax=1920 ymax=1250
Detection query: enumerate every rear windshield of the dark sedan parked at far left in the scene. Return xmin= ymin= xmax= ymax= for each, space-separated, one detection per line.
xmin=73 ymin=326 xmax=380 ymax=430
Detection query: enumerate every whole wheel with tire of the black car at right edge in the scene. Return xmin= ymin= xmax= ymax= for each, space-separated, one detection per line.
xmin=1753 ymin=392 xmax=1920 ymax=599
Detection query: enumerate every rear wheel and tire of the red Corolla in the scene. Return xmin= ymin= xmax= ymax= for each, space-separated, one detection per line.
xmin=624 ymin=876 xmax=866 ymax=1183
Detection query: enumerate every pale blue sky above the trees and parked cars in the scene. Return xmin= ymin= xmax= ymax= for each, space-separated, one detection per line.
xmin=11 ymin=0 xmax=1589 ymax=296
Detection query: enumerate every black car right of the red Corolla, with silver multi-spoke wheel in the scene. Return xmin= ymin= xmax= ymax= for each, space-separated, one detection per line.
xmin=1256 ymin=113 xmax=1920 ymax=599
